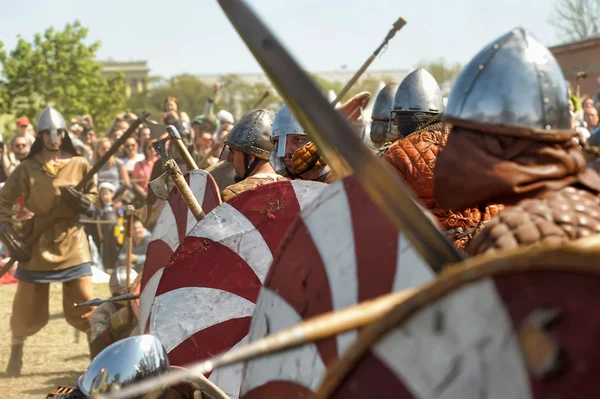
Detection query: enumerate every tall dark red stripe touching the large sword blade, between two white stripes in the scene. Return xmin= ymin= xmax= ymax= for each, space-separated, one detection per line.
xmin=342 ymin=176 xmax=398 ymax=302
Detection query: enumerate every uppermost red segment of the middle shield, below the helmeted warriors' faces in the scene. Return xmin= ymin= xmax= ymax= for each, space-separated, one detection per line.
xmin=229 ymin=181 xmax=300 ymax=252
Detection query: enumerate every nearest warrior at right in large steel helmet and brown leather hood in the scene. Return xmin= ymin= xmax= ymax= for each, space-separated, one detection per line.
xmin=435 ymin=28 xmax=600 ymax=254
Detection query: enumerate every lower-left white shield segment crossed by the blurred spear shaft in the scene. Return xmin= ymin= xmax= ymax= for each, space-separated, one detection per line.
xmin=241 ymin=287 xmax=326 ymax=396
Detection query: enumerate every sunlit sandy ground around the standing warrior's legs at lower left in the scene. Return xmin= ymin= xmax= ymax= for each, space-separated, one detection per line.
xmin=0 ymin=284 xmax=109 ymax=399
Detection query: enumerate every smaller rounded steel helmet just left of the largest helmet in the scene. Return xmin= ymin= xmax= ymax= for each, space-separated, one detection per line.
xmin=392 ymin=68 xmax=444 ymax=114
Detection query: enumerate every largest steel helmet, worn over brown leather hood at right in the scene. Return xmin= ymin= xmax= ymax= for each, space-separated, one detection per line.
xmin=446 ymin=28 xmax=571 ymax=136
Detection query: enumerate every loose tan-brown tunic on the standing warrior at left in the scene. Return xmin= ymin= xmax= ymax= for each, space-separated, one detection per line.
xmin=0 ymin=155 xmax=98 ymax=271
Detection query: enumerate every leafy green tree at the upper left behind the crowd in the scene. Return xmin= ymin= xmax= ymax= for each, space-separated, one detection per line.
xmin=0 ymin=21 xmax=126 ymax=131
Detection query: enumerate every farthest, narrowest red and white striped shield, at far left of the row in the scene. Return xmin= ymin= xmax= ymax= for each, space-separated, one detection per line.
xmin=139 ymin=170 xmax=221 ymax=331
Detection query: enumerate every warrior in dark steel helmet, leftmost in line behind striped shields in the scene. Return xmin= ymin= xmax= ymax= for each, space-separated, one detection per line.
xmin=221 ymin=109 xmax=287 ymax=201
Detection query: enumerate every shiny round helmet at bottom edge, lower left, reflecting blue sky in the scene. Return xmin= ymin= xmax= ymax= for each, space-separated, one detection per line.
xmin=77 ymin=335 xmax=169 ymax=398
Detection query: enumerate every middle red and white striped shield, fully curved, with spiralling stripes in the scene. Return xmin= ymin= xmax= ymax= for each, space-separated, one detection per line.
xmin=149 ymin=181 xmax=328 ymax=397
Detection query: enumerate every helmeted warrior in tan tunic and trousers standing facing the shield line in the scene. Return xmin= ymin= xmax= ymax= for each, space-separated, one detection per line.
xmin=0 ymin=107 xmax=98 ymax=376
